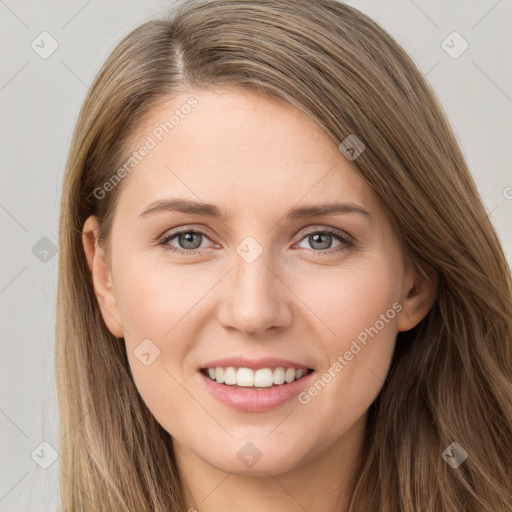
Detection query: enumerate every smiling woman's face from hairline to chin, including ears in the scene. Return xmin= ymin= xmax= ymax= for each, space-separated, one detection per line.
xmin=84 ymin=89 xmax=431 ymax=475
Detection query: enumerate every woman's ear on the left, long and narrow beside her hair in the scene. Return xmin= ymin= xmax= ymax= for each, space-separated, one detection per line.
xmin=82 ymin=215 xmax=124 ymax=338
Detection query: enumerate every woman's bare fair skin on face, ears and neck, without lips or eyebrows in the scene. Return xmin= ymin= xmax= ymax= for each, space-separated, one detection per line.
xmin=83 ymin=88 xmax=435 ymax=512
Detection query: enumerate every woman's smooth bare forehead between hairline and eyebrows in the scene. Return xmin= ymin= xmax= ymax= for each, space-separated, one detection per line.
xmin=115 ymin=88 xmax=374 ymax=214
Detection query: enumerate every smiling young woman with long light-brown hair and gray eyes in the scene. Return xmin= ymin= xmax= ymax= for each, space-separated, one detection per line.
xmin=57 ymin=0 xmax=512 ymax=512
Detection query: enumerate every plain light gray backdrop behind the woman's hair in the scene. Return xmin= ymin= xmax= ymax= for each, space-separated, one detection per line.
xmin=0 ymin=0 xmax=512 ymax=512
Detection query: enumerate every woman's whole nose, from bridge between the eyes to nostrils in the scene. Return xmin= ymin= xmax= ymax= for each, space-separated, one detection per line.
xmin=220 ymin=237 xmax=291 ymax=334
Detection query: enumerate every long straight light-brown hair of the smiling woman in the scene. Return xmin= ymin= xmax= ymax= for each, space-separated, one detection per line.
xmin=56 ymin=0 xmax=512 ymax=512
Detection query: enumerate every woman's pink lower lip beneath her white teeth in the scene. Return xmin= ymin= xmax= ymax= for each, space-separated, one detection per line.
xmin=198 ymin=372 xmax=315 ymax=412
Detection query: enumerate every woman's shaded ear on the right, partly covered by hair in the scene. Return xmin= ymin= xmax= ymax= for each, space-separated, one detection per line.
xmin=398 ymin=264 xmax=438 ymax=331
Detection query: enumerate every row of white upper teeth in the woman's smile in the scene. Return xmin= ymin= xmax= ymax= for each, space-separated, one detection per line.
xmin=208 ymin=366 xmax=308 ymax=388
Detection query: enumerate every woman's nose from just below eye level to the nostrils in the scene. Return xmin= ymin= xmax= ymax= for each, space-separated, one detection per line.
xmin=218 ymin=252 xmax=293 ymax=336
